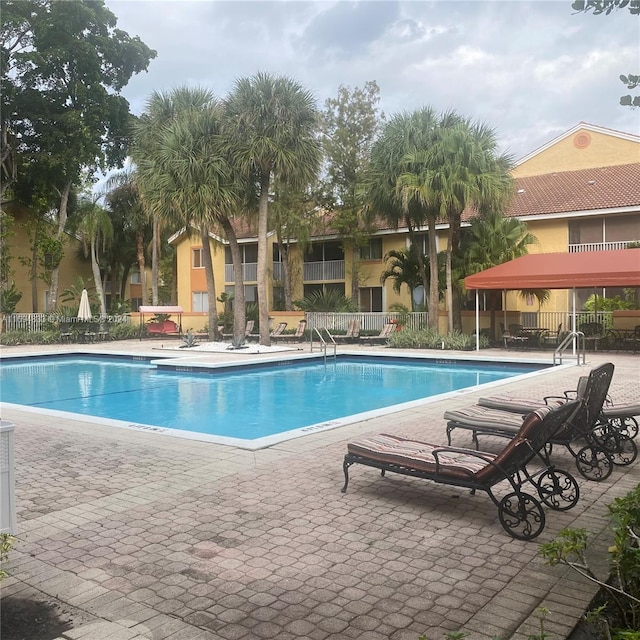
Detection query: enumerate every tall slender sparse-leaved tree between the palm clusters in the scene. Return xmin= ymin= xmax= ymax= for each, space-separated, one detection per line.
xmin=320 ymin=80 xmax=384 ymax=304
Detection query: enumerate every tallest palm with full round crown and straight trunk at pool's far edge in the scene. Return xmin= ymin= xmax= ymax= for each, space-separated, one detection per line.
xmin=226 ymin=73 xmax=320 ymax=346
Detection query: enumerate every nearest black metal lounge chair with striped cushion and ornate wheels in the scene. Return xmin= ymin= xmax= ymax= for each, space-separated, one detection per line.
xmin=342 ymin=401 xmax=580 ymax=540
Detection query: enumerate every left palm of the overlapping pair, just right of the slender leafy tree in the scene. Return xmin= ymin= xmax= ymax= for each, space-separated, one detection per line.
xmin=368 ymin=107 xmax=439 ymax=330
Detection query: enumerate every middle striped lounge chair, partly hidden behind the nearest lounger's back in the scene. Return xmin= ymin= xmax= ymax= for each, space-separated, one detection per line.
xmin=444 ymin=363 xmax=638 ymax=481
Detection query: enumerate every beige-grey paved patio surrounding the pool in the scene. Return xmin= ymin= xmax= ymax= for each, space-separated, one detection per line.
xmin=2 ymin=341 xmax=640 ymax=640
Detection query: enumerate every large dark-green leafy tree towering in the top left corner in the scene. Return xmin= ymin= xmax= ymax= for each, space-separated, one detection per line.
xmin=1 ymin=0 xmax=156 ymax=309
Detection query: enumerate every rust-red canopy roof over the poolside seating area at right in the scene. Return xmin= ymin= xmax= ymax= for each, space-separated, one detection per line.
xmin=464 ymin=249 xmax=640 ymax=289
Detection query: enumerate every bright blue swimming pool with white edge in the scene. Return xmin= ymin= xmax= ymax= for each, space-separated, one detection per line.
xmin=0 ymin=355 xmax=543 ymax=449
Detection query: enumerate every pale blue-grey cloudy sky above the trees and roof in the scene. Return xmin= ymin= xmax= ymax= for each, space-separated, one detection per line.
xmin=106 ymin=0 xmax=640 ymax=165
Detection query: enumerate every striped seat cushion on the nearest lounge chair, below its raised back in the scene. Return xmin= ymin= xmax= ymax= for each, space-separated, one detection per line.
xmin=347 ymin=433 xmax=496 ymax=479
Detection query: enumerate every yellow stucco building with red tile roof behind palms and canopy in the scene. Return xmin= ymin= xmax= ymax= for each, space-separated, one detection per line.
xmin=170 ymin=123 xmax=640 ymax=329
